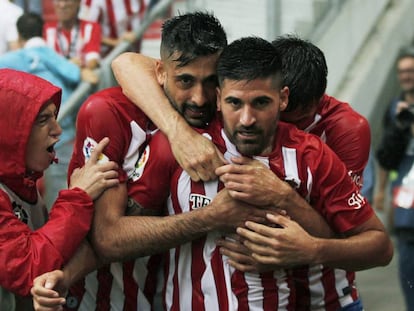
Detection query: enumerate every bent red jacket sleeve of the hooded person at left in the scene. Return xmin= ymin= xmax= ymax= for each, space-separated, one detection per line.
xmin=0 ymin=189 xmax=93 ymax=296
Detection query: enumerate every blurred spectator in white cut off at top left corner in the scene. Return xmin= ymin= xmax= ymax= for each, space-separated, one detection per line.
xmin=0 ymin=0 xmax=23 ymax=55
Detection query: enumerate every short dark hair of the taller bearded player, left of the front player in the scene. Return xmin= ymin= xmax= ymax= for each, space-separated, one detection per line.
xmin=160 ymin=11 xmax=227 ymax=66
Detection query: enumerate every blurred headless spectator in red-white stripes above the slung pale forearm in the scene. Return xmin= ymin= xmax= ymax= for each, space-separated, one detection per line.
xmin=79 ymin=0 xmax=150 ymax=55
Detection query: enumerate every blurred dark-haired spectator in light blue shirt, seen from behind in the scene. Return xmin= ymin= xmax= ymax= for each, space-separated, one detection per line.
xmin=0 ymin=13 xmax=97 ymax=206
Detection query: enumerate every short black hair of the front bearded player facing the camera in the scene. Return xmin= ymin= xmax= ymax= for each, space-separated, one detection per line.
xmin=217 ymin=37 xmax=282 ymax=86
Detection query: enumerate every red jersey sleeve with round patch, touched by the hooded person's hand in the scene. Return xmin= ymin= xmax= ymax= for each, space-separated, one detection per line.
xmin=68 ymin=95 xmax=129 ymax=182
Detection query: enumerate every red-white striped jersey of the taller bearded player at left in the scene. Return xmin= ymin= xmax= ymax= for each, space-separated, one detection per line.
xmin=67 ymin=87 xmax=158 ymax=311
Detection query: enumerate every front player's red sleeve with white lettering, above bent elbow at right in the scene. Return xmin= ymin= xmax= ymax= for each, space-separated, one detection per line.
xmin=308 ymin=142 xmax=373 ymax=232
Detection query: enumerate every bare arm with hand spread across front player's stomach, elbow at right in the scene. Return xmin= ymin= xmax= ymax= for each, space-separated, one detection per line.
xmin=228 ymin=210 xmax=393 ymax=271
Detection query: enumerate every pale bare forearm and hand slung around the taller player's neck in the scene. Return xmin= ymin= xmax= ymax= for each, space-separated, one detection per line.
xmin=112 ymin=53 xmax=223 ymax=181
